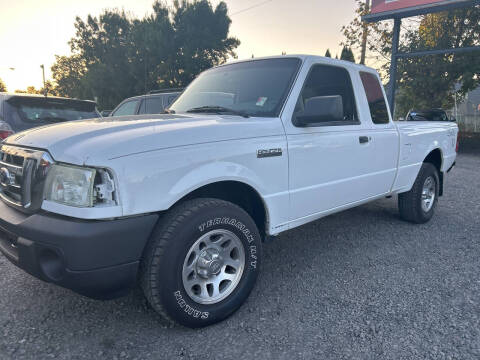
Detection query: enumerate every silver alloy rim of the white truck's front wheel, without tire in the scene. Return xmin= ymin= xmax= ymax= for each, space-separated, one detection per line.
xmin=182 ymin=229 xmax=245 ymax=305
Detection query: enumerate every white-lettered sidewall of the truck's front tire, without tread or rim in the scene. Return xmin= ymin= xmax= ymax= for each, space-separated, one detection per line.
xmin=163 ymin=204 xmax=262 ymax=327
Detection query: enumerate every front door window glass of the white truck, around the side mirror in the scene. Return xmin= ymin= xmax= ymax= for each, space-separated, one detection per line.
xmin=295 ymin=65 xmax=358 ymax=125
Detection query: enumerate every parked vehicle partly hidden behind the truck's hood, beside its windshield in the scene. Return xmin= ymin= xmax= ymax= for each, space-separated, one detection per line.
xmin=110 ymin=89 xmax=183 ymax=116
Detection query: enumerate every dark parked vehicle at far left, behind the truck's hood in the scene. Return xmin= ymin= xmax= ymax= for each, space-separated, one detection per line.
xmin=0 ymin=93 xmax=100 ymax=140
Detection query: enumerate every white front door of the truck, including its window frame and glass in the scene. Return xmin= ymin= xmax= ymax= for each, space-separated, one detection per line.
xmin=283 ymin=63 xmax=382 ymax=222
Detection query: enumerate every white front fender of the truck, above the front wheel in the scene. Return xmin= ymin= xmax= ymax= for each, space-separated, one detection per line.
xmin=111 ymin=136 xmax=289 ymax=233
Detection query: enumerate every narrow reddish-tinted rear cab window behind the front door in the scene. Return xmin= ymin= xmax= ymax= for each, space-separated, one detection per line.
xmin=360 ymin=72 xmax=390 ymax=125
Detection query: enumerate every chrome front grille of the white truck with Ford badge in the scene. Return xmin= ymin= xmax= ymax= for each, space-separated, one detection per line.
xmin=0 ymin=145 xmax=53 ymax=212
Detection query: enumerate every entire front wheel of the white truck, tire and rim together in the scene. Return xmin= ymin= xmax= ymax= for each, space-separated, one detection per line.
xmin=140 ymin=199 xmax=261 ymax=328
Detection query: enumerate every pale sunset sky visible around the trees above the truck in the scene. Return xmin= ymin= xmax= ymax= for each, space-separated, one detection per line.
xmin=0 ymin=0 xmax=355 ymax=92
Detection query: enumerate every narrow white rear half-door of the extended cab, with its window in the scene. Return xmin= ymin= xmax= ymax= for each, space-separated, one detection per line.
xmin=359 ymin=71 xmax=400 ymax=193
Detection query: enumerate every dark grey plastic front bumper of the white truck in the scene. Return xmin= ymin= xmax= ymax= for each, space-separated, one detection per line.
xmin=0 ymin=201 xmax=158 ymax=299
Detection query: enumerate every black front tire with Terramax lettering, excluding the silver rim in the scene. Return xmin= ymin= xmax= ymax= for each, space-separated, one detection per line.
xmin=139 ymin=198 xmax=261 ymax=328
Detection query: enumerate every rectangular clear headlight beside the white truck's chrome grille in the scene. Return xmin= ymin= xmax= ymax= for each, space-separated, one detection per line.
xmin=45 ymin=165 xmax=96 ymax=207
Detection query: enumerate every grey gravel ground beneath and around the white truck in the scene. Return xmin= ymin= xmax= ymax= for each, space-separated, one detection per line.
xmin=0 ymin=154 xmax=480 ymax=359
